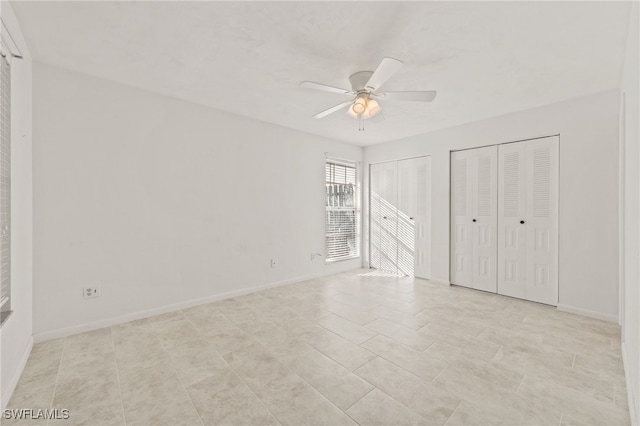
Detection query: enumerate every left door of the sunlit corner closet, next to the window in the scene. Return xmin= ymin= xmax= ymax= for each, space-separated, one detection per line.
xmin=370 ymin=161 xmax=398 ymax=272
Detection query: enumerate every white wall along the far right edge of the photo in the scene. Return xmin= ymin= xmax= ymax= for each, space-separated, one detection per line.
xmin=620 ymin=3 xmax=640 ymax=424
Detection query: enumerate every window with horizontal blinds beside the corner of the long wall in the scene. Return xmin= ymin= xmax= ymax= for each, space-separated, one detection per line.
xmin=325 ymin=158 xmax=360 ymax=262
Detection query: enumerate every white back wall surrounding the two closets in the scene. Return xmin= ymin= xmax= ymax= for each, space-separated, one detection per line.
xmin=364 ymin=90 xmax=620 ymax=321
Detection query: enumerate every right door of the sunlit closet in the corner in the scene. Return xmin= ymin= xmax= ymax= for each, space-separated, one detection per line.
xmin=398 ymin=157 xmax=431 ymax=278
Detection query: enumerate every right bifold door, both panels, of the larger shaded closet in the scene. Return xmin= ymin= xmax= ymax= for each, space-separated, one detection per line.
xmin=498 ymin=137 xmax=558 ymax=305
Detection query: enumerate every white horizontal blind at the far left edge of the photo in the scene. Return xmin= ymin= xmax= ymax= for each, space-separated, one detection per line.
xmin=0 ymin=57 xmax=11 ymax=317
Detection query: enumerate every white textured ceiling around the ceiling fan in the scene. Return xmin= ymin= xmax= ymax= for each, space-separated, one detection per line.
xmin=12 ymin=1 xmax=630 ymax=145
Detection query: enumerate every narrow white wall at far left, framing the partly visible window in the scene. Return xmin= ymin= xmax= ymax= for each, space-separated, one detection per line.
xmin=0 ymin=1 xmax=33 ymax=408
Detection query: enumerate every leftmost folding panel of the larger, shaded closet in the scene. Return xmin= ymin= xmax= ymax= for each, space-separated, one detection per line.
xmin=450 ymin=150 xmax=475 ymax=287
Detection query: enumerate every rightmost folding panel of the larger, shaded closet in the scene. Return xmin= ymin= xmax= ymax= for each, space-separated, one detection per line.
xmin=525 ymin=136 xmax=559 ymax=305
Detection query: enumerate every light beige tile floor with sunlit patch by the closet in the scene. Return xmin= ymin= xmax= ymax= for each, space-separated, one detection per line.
xmin=4 ymin=270 xmax=629 ymax=425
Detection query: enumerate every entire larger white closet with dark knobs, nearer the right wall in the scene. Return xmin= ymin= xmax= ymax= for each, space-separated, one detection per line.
xmin=450 ymin=136 xmax=559 ymax=305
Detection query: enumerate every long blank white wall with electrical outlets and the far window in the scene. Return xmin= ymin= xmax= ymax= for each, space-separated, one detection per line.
xmin=34 ymin=63 xmax=362 ymax=341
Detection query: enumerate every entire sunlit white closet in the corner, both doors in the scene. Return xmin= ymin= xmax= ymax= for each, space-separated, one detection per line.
xmin=369 ymin=156 xmax=431 ymax=278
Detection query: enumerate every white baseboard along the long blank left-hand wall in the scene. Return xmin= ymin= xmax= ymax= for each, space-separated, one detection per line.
xmin=33 ymin=268 xmax=340 ymax=343
